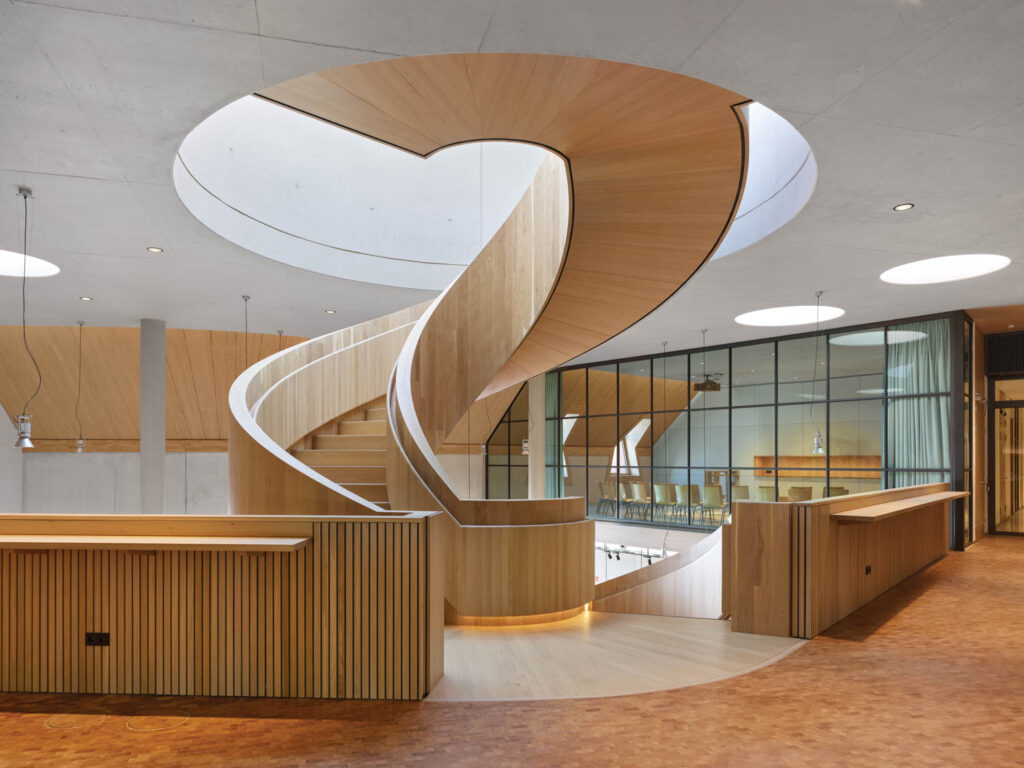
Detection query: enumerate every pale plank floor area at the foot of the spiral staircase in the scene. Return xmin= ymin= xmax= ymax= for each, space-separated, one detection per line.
xmin=427 ymin=612 xmax=803 ymax=701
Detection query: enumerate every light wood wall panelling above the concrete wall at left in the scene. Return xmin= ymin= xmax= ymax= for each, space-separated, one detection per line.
xmin=0 ymin=326 xmax=304 ymax=452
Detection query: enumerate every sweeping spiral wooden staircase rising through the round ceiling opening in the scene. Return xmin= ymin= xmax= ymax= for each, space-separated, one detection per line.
xmin=230 ymin=54 xmax=745 ymax=623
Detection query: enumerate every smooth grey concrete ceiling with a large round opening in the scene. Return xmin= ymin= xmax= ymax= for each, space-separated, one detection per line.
xmin=0 ymin=0 xmax=1024 ymax=352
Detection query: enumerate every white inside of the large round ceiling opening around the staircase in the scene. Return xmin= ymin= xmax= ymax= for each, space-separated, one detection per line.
xmin=174 ymin=87 xmax=817 ymax=291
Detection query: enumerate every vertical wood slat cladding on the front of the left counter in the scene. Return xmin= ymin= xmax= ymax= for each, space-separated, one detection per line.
xmin=0 ymin=518 xmax=443 ymax=699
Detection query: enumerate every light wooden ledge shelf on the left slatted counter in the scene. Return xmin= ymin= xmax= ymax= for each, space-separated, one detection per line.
xmin=0 ymin=534 xmax=309 ymax=552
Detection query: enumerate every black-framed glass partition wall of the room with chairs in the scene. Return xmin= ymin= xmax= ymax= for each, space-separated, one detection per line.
xmin=487 ymin=315 xmax=961 ymax=529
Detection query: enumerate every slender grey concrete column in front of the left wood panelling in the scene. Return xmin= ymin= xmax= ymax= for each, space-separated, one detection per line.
xmin=138 ymin=319 xmax=167 ymax=515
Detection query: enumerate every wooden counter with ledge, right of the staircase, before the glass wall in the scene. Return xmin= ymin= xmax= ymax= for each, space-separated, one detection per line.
xmin=723 ymin=483 xmax=969 ymax=638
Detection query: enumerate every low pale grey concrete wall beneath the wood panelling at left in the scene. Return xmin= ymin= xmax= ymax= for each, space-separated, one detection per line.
xmin=18 ymin=450 xmax=228 ymax=515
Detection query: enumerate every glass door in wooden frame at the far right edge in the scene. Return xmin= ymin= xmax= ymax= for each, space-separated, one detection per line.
xmin=989 ymin=379 xmax=1024 ymax=534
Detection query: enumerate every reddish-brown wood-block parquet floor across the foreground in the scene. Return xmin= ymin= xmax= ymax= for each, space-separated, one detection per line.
xmin=0 ymin=537 xmax=1024 ymax=768
